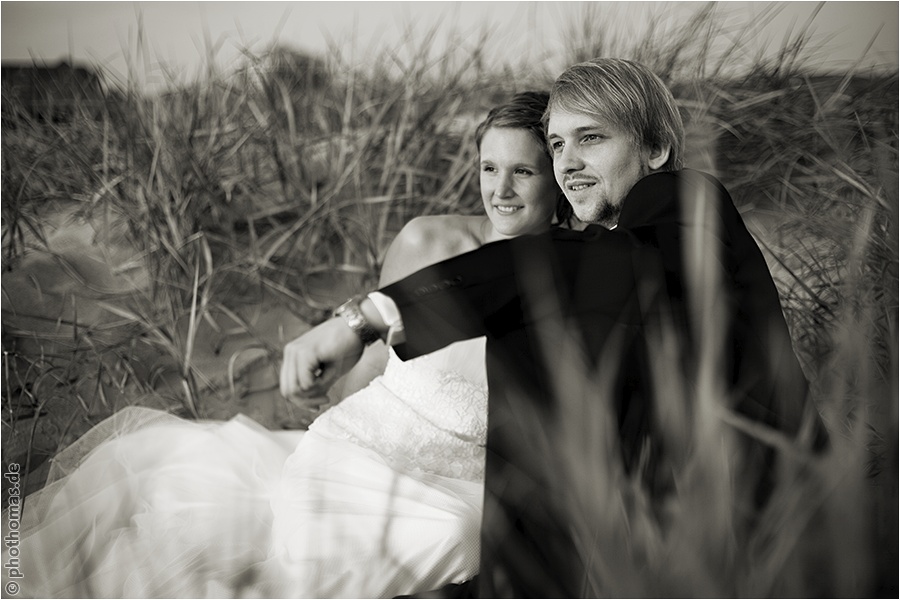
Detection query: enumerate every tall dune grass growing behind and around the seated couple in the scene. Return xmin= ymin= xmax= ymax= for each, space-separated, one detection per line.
xmin=2 ymin=5 xmax=898 ymax=597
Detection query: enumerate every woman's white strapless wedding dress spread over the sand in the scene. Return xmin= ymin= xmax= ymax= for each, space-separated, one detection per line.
xmin=3 ymin=339 xmax=487 ymax=598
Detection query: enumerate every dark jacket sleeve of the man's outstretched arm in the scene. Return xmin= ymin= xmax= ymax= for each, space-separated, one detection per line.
xmin=380 ymin=227 xmax=648 ymax=360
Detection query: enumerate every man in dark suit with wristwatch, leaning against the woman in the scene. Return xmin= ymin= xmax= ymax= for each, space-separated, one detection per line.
xmin=281 ymin=59 xmax=824 ymax=597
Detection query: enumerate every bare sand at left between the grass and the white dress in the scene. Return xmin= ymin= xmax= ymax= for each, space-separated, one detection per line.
xmin=2 ymin=202 xmax=346 ymax=491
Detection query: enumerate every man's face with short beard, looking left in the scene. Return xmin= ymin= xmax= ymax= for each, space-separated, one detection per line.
xmin=547 ymin=109 xmax=656 ymax=228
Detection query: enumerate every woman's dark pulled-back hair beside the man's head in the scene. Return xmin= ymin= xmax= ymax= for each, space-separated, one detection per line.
xmin=475 ymin=91 xmax=572 ymax=223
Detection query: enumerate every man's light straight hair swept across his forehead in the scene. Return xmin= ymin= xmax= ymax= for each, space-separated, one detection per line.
xmin=543 ymin=58 xmax=684 ymax=171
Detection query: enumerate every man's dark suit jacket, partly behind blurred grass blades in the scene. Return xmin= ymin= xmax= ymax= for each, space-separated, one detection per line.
xmin=381 ymin=171 xmax=824 ymax=597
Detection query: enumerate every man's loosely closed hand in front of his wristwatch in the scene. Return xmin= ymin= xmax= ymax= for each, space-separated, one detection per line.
xmin=281 ymin=317 xmax=363 ymax=405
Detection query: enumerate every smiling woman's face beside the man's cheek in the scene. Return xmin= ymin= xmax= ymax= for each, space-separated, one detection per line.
xmin=480 ymin=127 xmax=559 ymax=237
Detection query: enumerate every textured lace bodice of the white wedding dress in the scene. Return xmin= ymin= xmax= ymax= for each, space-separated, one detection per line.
xmin=310 ymin=338 xmax=487 ymax=481
